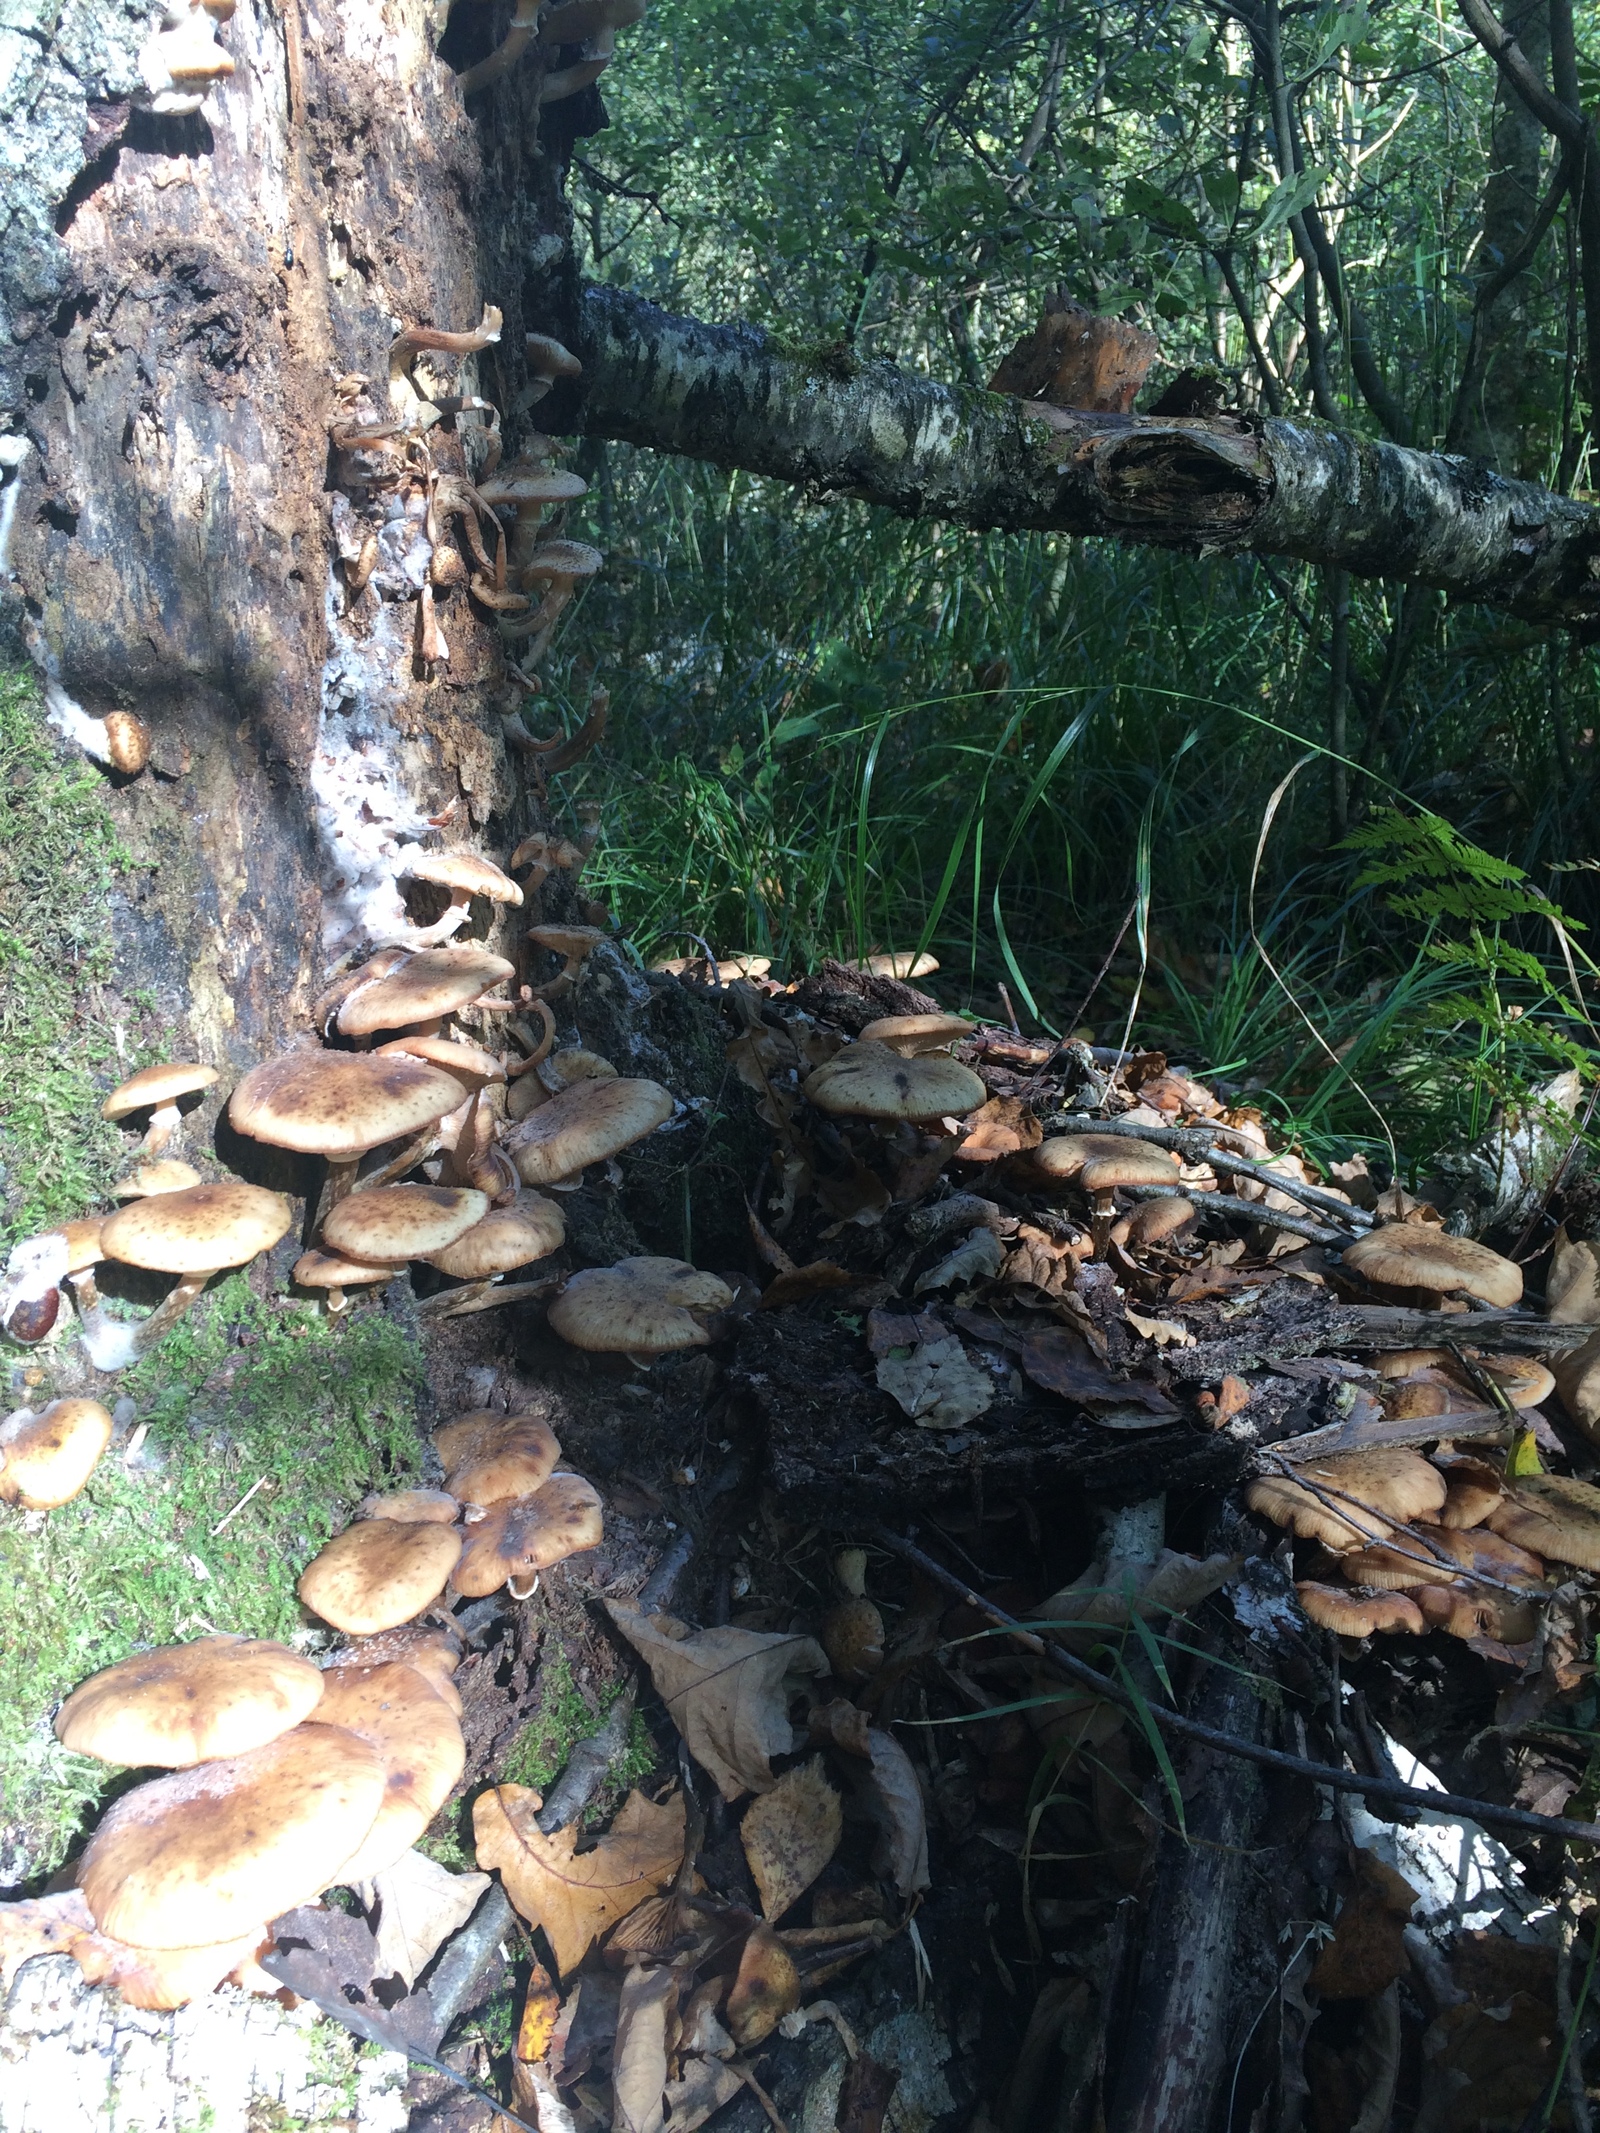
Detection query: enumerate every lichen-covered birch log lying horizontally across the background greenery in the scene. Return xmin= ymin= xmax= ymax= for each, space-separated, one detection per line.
xmin=567 ymin=286 xmax=1600 ymax=634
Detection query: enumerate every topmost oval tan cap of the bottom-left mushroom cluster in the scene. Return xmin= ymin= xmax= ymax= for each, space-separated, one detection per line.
xmin=55 ymin=1636 xmax=322 ymax=1770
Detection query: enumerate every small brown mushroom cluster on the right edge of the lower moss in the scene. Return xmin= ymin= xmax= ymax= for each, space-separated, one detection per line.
xmin=299 ymin=1410 xmax=604 ymax=1636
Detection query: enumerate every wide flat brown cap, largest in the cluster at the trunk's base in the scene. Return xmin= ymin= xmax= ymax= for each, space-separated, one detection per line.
xmin=228 ymin=1045 xmax=461 ymax=1162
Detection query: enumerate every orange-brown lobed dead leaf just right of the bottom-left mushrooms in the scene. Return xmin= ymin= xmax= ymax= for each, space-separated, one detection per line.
xmin=471 ymin=1785 xmax=685 ymax=1977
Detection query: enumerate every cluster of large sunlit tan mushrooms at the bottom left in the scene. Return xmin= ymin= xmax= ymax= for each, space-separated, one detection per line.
xmin=39 ymin=1627 xmax=465 ymax=2007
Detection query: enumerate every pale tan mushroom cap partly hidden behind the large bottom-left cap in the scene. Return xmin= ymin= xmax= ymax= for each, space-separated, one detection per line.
xmin=318 ymin=1662 xmax=467 ymax=1883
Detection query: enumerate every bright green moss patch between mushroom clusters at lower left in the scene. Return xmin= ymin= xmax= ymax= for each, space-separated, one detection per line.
xmin=0 ymin=1276 xmax=420 ymax=1881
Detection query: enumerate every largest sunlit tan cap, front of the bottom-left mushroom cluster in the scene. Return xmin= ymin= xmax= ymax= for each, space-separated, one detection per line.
xmin=79 ymin=1721 xmax=384 ymax=1947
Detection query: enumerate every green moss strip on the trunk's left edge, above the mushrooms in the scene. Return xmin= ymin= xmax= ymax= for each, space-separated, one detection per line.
xmin=0 ymin=674 xmax=137 ymax=1254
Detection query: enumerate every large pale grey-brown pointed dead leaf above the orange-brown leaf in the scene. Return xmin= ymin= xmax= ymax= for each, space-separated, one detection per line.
xmin=606 ymin=1600 xmax=828 ymax=1817
